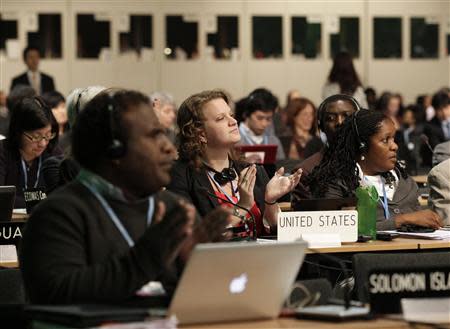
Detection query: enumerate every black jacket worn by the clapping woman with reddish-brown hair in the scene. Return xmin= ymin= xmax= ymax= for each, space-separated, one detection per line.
xmin=167 ymin=160 xmax=269 ymax=216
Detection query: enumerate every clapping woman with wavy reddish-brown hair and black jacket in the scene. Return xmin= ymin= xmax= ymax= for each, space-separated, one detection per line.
xmin=167 ymin=90 xmax=301 ymax=236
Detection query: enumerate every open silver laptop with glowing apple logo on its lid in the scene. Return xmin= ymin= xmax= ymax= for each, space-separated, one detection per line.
xmin=169 ymin=241 xmax=307 ymax=324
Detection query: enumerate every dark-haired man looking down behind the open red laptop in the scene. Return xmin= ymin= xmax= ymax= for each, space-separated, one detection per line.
xmin=239 ymin=95 xmax=285 ymax=162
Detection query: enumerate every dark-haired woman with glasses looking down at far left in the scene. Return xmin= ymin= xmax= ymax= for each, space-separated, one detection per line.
xmin=0 ymin=96 xmax=61 ymax=208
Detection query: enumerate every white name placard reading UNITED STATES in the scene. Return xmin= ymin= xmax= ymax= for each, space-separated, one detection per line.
xmin=278 ymin=210 xmax=358 ymax=242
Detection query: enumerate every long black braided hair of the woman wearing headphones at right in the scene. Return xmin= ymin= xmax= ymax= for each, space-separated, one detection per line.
xmin=305 ymin=109 xmax=394 ymax=198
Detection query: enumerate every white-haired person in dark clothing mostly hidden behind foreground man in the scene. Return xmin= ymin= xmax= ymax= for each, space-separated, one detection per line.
xmin=42 ymin=86 xmax=106 ymax=193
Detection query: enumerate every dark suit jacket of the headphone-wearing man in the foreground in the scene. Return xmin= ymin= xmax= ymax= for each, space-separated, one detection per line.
xmin=20 ymin=181 xmax=183 ymax=305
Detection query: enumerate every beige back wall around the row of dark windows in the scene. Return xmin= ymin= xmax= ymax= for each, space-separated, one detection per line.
xmin=0 ymin=0 xmax=450 ymax=102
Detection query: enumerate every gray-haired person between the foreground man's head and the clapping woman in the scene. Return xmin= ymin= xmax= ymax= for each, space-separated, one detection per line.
xmin=150 ymin=91 xmax=177 ymax=143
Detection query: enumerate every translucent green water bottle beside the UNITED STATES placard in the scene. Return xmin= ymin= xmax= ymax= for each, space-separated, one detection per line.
xmin=356 ymin=186 xmax=378 ymax=240
